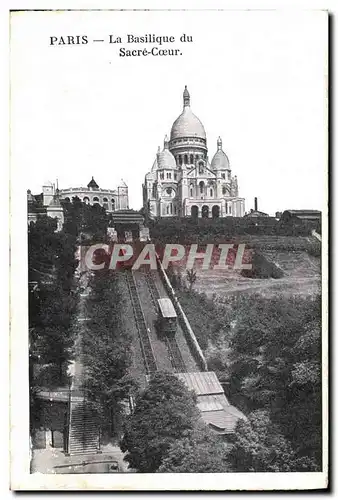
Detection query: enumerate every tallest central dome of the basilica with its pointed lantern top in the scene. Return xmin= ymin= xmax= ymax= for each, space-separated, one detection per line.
xmin=170 ymin=87 xmax=206 ymax=140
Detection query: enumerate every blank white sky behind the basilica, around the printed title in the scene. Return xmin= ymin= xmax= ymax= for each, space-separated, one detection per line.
xmin=11 ymin=10 xmax=327 ymax=214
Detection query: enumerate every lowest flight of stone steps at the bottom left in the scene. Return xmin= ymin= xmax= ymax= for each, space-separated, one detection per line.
xmin=68 ymin=397 xmax=100 ymax=455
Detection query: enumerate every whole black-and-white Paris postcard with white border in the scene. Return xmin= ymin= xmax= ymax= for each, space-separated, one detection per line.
xmin=10 ymin=9 xmax=328 ymax=491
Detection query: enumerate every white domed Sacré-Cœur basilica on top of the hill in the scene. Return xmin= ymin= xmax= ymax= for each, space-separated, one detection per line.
xmin=143 ymin=87 xmax=245 ymax=218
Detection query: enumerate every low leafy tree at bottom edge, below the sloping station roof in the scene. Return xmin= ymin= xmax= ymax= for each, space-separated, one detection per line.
xmin=157 ymin=422 xmax=229 ymax=473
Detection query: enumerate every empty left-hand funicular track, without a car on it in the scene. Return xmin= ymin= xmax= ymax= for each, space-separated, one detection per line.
xmin=125 ymin=271 xmax=157 ymax=375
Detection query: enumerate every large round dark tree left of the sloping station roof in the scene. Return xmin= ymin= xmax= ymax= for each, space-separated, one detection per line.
xmin=121 ymin=372 xmax=200 ymax=472
